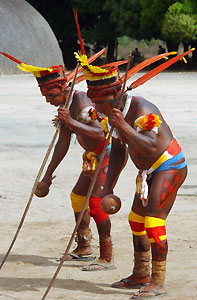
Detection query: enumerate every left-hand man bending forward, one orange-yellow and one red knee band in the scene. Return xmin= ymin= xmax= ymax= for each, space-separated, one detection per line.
xmin=35 ymin=66 xmax=118 ymax=271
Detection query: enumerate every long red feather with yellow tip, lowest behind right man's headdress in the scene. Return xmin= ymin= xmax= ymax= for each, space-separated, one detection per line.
xmin=129 ymin=49 xmax=194 ymax=89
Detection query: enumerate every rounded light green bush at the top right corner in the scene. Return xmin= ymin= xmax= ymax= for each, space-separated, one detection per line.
xmin=161 ymin=1 xmax=197 ymax=43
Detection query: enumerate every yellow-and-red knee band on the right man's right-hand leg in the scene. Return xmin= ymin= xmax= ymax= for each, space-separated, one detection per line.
xmin=145 ymin=216 xmax=166 ymax=244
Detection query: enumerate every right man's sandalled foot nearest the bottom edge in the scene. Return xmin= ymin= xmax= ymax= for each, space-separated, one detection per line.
xmin=131 ymin=282 xmax=167 ymax=299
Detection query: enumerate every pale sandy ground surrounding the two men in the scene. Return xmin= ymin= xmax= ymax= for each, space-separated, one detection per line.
xmin=0 ymin=72 xmax=197 ymax=300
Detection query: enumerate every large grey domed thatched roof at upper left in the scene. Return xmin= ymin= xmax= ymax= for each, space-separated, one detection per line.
xmin=0 ymin=0 xmax=63 ymax=74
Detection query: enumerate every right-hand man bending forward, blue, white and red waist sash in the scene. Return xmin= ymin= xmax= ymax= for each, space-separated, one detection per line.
xmin=76 ymin=54 xmax=187 ymax=299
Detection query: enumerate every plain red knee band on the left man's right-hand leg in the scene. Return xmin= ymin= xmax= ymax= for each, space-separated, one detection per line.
xmin=89 ymin=197 xmax=109 ymax=224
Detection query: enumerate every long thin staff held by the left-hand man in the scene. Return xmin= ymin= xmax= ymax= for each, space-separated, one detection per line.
xmin=0 ymin=63 xmax=79 ymax=270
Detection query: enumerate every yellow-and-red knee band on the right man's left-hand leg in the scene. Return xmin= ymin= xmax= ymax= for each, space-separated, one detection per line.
xmin=128 ymin=210 xmax=146 ymax=235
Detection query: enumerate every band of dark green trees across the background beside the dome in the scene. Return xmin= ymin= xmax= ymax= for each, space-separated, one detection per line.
xmin=26 ymin=0 xmax=197 ymax=67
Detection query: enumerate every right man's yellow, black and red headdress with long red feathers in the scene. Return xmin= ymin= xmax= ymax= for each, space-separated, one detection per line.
xmin=73 ymin=9 xmax=195 ymax=97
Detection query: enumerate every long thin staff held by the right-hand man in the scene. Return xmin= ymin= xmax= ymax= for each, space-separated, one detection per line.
xmin=41 ymin=54 xmax=131 ymax=300
